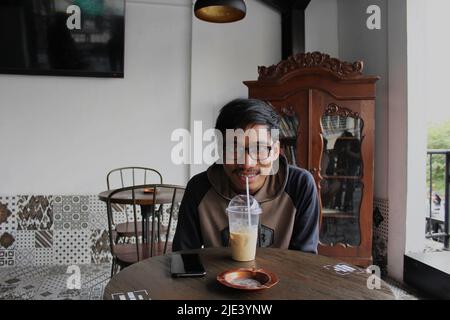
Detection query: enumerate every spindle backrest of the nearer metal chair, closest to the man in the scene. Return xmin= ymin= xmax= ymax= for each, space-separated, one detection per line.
xmin=106 ymin=184 xmax=185 ymax=261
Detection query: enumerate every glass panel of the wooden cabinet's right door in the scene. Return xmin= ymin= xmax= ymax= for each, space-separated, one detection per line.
xmin=320 ymin=108 xmax=364 ymax=246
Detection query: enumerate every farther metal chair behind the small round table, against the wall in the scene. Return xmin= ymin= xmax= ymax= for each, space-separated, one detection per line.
xmin=106 ymin=167 xmax=163 ymax=241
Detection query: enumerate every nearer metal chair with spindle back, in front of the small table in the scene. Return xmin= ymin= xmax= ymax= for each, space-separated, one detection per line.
xmin=106 ymin=184 xmax=185 ymax=277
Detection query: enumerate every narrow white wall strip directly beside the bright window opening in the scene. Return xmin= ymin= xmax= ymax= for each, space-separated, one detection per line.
xmin=388 ymin=0 xmax=410 ymax=280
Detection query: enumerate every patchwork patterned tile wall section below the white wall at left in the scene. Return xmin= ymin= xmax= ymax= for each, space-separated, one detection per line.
xmin=0 ymin=195 xmax=111 ymax=268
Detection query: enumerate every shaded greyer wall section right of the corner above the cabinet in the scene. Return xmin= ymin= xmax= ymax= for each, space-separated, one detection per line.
xmin=338 ymin=0 xmax=388 ymax=199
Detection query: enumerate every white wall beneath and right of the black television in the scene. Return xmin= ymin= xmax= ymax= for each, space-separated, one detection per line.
xmin=0 ymin=1 xmax=191 ymax=195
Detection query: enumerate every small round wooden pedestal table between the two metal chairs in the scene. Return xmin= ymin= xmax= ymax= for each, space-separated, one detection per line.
xmin=98 ymin=188 xmax=173 ymax=243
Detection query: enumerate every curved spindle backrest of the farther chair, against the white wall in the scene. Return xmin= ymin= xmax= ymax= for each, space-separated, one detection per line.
xmin=106 ymin=167 xmax=163 ymax=190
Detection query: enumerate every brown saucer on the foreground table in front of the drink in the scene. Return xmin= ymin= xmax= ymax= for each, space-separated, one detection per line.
xmin=217 ymin=268 xmax=278 ymax=291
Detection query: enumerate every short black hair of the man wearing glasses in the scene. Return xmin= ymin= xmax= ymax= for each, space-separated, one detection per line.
xmin=216 ymin=99 xmax=280 ymax=132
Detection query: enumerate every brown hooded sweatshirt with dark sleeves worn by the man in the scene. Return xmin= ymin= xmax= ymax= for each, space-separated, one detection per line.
xmin=172 ymin=157 xmax=320 ymax=253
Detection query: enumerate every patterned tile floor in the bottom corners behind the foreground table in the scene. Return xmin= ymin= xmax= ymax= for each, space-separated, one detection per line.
xmin=0 ymin=263 xmax=419 ymax=300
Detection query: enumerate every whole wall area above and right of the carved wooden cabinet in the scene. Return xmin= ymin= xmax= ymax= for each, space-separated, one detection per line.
xmin=305 ymin=0 xmax=388 ymax=199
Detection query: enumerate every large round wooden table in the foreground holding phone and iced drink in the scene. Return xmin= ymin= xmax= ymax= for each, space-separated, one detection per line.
xmin=103 ymin=248 xmax=395 ymax=300
